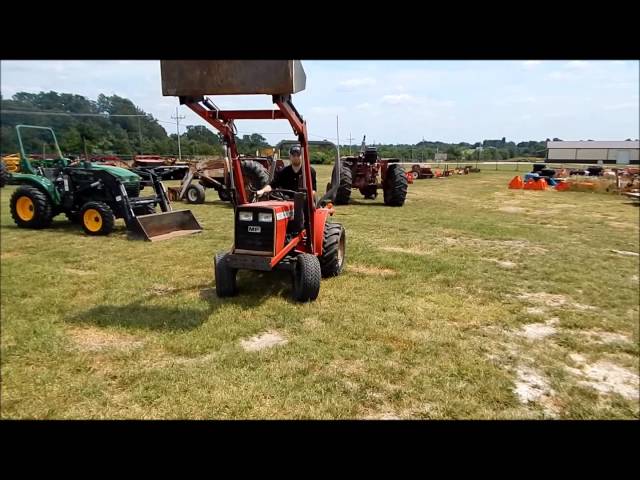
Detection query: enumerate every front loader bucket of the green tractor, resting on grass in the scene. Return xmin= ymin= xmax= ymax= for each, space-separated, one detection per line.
xmin=129 ymin=210 xmax=202 ymax=242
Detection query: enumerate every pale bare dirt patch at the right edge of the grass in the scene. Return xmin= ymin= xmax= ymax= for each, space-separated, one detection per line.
xmin=565 ymin=354 xmax=640 ymax=401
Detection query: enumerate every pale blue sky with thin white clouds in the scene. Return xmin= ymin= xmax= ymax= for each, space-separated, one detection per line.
xmin=0 ymin=60 xmax=640 ymax=144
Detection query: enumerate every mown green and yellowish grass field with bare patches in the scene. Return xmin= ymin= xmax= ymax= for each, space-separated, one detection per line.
xmin=0 ymin=166 xmax=640 ymax=419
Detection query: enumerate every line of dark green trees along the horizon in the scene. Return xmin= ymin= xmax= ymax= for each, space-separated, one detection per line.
xmin=0 ymin=91 xmax=559 ymax=164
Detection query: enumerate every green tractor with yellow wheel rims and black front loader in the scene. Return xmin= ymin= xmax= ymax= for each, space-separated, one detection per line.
xmin=8 ymin=125 xmax=202 ymax=241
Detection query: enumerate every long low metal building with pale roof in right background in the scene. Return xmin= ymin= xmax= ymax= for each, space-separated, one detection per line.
xmin=546 ymin=140 xmax=640 ymax=165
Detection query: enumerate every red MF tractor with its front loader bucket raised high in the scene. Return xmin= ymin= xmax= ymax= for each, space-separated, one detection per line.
xmin=161 ymin=60 xmax=346 ymax=302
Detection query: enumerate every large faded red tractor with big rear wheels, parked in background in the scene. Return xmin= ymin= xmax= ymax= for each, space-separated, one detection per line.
xmin=327 ymin=136 xmax=408 ymax=207
